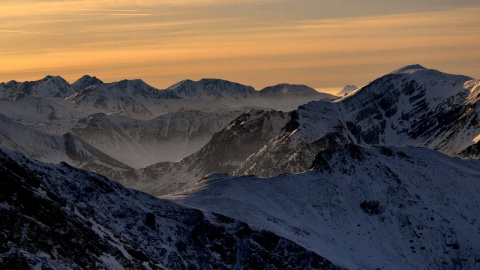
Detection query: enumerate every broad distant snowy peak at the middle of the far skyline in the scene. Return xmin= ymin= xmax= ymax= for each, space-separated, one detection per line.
xmin=167 ymin=79 xmax=256 ymax=99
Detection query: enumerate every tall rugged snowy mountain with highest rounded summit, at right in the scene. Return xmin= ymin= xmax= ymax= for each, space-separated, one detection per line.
xmin=237 ymin=65 xmax=480 ymax=176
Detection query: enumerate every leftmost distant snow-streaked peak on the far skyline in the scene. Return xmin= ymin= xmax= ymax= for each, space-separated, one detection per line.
xmin=0 ymin=76 xmax=76 ymax=100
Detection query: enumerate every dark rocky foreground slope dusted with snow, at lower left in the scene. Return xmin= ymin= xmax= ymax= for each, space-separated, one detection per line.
xmin=0 ymin=150 xmax=341 ymax=270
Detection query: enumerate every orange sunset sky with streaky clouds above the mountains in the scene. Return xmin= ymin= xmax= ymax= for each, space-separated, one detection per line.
xmin=0 ymin=0 xmax=480 ymax=92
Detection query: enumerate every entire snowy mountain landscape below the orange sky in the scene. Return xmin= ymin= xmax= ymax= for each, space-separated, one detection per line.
xmin=0 ymin=65 xmax=480 ymax=269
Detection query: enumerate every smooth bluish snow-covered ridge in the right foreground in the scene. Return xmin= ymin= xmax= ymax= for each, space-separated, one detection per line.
xmin=167 ymin=144 xmax=480 ymax=269
